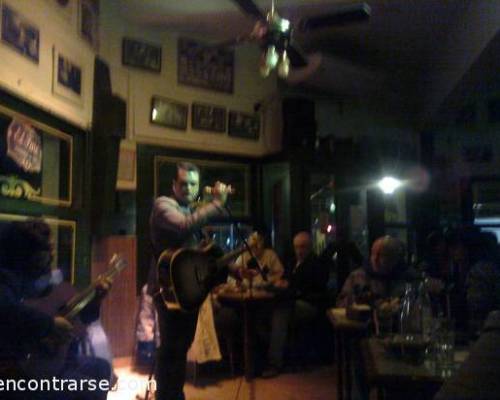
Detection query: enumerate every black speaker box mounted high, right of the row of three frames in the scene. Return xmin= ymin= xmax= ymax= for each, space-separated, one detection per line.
xmin=283 ymin=98 xmax=316 ymax=150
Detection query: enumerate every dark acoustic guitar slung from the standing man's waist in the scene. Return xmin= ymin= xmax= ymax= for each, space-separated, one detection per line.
xmin=157 ymin=244 xmax=246 ymax=311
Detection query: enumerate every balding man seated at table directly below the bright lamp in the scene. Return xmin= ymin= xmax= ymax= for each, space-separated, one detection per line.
xmin=337 ymin=236 xmax=416 ymax=307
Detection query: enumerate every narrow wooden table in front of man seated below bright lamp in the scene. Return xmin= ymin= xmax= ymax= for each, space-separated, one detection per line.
xmin=326 ymin=308 xmax=370 ymax=400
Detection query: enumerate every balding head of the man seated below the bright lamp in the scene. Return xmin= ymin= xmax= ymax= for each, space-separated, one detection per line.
xmin=370 ymin=236 xmax=404 ymax=274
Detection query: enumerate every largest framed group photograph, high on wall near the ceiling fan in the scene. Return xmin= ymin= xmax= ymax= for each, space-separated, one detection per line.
xmin=177 ymin=38 xmax=234 ymax=93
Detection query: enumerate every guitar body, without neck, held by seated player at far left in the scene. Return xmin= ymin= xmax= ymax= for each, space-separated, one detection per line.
xmin=18 ymin=282 xmax=85 ymax=379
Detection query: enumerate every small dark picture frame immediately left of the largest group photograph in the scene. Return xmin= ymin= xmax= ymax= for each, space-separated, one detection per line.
xmin=122 ymin=37 xmax=161 ymax=73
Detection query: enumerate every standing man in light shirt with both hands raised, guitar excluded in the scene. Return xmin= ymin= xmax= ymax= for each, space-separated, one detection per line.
xmin=148 ymin=162 xmax=231 ymax=400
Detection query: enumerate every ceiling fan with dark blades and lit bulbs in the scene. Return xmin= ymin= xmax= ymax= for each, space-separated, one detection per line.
xmin=225 ymin=0 xmax=371 ymax=83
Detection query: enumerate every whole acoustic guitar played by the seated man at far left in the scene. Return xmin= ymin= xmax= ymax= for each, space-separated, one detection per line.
xmin=17 ymin=254 xmax=127 ymax=378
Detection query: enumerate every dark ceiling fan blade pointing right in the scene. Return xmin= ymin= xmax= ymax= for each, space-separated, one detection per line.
xmin=299 ymin=3 xmax=371 ymax=31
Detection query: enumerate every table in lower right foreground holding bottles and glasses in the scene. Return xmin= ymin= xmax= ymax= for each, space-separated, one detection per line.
xmin=361 ymin=338 xmax=468 ymax=400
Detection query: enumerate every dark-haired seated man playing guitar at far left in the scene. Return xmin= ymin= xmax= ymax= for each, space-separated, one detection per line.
xmin=0 ymin=220 xmax=111 ymax=400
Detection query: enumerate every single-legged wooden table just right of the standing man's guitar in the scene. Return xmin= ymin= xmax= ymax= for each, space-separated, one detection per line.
xmin=217 ymin=289 xmax=275 ymax=381
